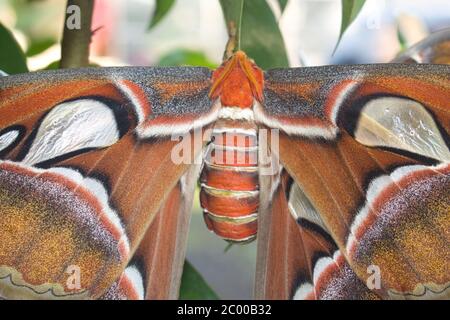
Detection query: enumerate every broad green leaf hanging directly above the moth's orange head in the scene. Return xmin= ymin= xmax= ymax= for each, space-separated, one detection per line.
xmin=220 ymin=0 xmax=289 ymax=69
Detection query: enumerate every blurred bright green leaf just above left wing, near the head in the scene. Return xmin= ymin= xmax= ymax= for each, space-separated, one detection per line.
xmin=157 ymin=49 xmax=217 ymax=69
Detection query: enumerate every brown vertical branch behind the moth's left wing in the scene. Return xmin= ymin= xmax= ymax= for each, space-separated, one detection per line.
xmin=60 ymin=0 xmax=95 ymax=68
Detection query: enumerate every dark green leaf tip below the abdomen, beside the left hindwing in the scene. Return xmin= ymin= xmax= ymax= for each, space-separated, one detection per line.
xmin=180 ymin=260 xmax=219 ymax=300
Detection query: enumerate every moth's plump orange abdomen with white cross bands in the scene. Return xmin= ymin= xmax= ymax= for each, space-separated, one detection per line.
xmin=200 ymin=119 xmax=259 ymax=243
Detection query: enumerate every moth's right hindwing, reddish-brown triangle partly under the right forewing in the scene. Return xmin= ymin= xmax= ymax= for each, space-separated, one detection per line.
xmin=255 ymin=158 xmax=379 ymax=300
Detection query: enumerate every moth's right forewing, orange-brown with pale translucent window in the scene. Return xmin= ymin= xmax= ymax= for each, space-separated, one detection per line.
xmin=255 ymin=65 xmax=450 ymax=298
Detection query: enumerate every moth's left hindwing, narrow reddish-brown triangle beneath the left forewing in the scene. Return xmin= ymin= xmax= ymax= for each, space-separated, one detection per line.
xmin=101 ymin=166 xmax=198 ymax=300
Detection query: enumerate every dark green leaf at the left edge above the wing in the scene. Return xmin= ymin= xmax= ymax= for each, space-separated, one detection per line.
xmin=0 ymin=23 xmax=28 ymax=74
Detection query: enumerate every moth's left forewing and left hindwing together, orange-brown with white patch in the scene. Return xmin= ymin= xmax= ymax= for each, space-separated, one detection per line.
xmin=0 ymin=68 xmax=216 ymax=298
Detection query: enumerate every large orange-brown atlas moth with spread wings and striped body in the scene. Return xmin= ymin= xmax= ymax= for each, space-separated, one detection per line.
xmin=0 ymin=31 xmax=450 ymax=299
